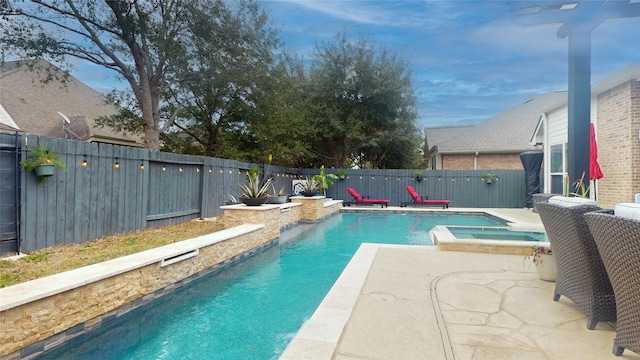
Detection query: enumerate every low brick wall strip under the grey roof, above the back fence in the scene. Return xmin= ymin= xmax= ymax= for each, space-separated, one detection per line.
xmin=442 ymin=153 xmax=522 ymax=170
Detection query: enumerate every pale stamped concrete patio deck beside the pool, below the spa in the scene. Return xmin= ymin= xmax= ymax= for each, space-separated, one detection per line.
xmin=281 ymin=209 xmax=640 ymax=360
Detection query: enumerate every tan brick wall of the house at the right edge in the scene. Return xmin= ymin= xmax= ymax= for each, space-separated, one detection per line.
xmin=597 ymin=80 xmax=640 ymax=207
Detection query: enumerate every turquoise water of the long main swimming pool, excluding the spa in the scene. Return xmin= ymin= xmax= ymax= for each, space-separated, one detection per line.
xmin=41 ymin=213 xmax=504 ymax=360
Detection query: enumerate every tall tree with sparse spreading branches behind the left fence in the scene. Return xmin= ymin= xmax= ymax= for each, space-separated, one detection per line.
xmin=0 ymin=0 xmax=264 ymax=150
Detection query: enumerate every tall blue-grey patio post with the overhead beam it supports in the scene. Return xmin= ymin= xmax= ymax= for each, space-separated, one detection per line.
xmin=510 ymin=0 xmax=640 ymax=188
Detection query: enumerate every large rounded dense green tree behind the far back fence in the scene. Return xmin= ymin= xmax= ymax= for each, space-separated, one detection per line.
xmin=308 ymin=35 xmax=420 ymax=168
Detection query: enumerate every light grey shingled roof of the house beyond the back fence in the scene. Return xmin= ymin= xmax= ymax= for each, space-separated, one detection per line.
xmin=425 ymin=91 xmax=567 ymax=154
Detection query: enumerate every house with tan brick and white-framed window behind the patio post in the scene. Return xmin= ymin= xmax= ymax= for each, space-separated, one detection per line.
xmin=531 ymin=61 xmax=640 ymax=206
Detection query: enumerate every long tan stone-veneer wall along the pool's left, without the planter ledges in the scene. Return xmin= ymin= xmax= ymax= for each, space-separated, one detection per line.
xmin=0 ymin=227 xmax=268 ymax=359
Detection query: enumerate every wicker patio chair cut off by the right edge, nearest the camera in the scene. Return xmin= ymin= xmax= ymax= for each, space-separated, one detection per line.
xmin=585 ymin=210 xmax=640 ymax=356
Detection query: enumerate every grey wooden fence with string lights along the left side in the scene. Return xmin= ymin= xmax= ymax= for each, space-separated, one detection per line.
xmin=15 ymin=135 xmax=293 ymax=252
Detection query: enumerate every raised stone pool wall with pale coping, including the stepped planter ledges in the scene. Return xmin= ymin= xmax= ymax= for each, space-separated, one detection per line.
xmin=0 ymin=197 xmax=342 ymax=359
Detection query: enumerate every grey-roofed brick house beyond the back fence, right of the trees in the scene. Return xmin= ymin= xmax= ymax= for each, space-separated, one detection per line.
xmin=425 ymin=91 xmax=567 ymax=170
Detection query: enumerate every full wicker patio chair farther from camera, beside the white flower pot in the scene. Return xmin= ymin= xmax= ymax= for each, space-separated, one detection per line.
xmin=536 ymin=203 xmax=616 ymax=330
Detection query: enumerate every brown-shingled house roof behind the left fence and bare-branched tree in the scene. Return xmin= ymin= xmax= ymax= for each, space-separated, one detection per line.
xmin=0 ymin=60 xmax=143 ymax=146
